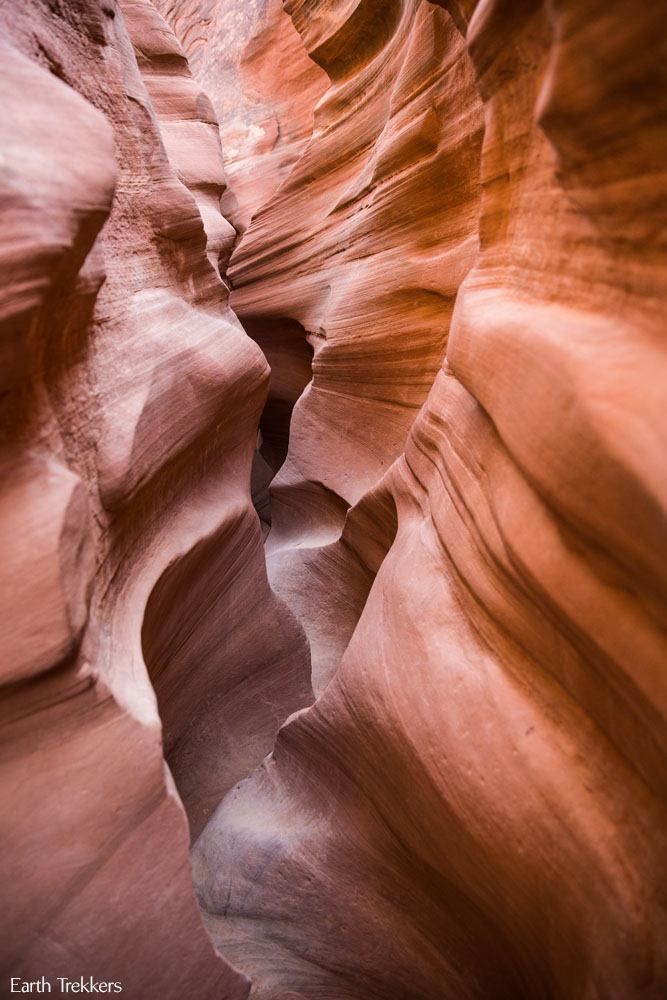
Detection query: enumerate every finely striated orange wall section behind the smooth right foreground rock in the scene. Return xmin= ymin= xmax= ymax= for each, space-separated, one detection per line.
xmin=193 ymin=0 xmax=482 ymax=674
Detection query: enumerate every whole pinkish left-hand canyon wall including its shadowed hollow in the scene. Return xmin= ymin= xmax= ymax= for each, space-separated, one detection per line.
xmin=0 ymin=0 xmax=311 ymax=1000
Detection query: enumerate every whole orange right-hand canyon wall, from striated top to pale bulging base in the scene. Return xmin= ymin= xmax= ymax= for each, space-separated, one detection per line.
xmin=185 ymin=0 xmax=667 ymax=1000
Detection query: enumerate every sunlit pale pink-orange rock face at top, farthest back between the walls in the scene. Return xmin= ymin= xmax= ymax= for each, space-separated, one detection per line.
xmin=155 ymin=0 xmax=328 ymax=232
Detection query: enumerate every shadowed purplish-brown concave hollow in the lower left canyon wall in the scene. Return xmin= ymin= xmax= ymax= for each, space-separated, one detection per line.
xmin=143 ymin=506 xmax=312 ymax=837
